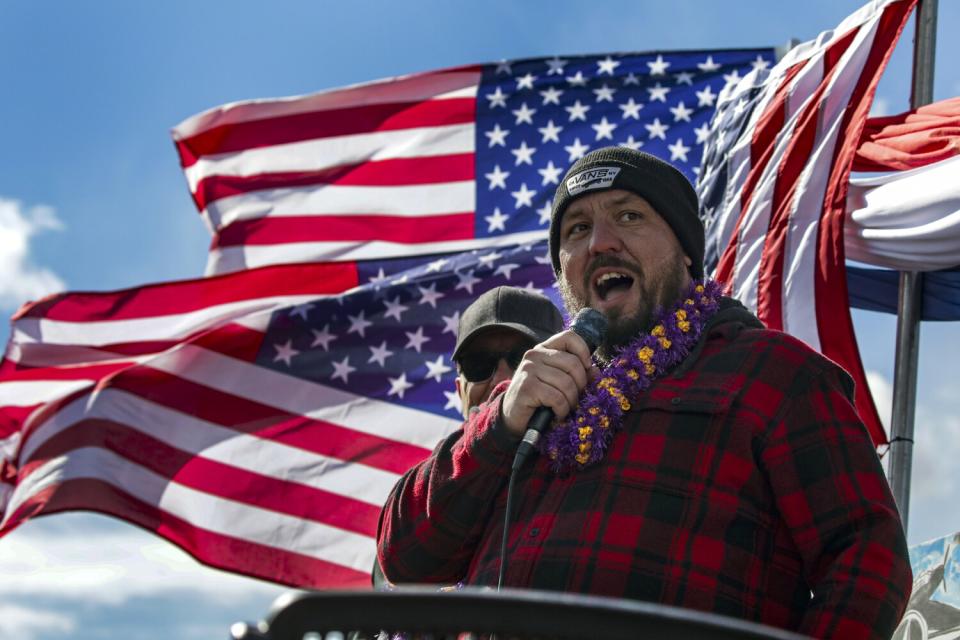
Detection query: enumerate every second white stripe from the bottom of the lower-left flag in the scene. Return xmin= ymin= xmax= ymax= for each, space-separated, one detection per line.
xmin=18 ymin=387 xmax=399 ymax=506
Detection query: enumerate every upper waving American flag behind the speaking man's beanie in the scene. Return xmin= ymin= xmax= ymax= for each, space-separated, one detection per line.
xmin=173 ymin=49 xmax=773 ymax=273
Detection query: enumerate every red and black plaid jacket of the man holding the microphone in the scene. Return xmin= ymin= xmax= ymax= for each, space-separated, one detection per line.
xmin=379 ymin=312 xmax=911 ymax=639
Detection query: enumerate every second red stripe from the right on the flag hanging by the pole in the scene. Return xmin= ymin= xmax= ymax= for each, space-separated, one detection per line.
xmin=757 ymin=29 xmax=859 ymax=329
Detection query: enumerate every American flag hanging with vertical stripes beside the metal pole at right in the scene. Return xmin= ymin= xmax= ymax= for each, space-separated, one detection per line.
xmin=698 ymin=0 xmax=916 ymax=445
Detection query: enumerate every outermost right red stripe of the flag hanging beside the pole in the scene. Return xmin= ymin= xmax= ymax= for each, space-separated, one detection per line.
xmin=813 ymin=0 xmax=916 ymax=445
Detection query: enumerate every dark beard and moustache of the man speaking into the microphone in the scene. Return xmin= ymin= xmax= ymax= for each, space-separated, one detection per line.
xmin=557 ymin=255 xmax=688 ymax=365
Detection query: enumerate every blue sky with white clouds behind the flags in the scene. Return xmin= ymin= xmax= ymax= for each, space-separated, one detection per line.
xmin=0 ymin=0 xmax=960 ymax=640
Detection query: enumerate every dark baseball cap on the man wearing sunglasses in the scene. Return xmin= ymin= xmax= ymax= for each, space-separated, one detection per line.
xmin=453 ymin=286 xmax=563 ymax=361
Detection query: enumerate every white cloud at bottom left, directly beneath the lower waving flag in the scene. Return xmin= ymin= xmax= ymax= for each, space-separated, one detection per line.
xmin=0 ymin=513 xmax=285 ymax=608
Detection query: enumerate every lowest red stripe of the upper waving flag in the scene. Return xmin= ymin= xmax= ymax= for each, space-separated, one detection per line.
xmin=211 ymin=212 xmax=474 ymax=249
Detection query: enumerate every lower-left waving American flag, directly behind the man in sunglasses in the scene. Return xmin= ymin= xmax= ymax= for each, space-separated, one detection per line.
xmin=0 ymin=246 xmax=553 ymax=587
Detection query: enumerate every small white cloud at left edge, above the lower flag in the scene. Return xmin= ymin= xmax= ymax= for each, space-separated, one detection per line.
xmin=0 ymin=198 xmax=64 ymax=308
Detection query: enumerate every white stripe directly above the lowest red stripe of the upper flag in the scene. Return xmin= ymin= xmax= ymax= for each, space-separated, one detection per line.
xmin=202 ymin=180 xmax=476 ymax=228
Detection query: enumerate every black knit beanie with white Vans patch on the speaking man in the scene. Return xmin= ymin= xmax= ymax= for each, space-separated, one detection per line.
xmin=550 ymin=147 xmax=704 ymax=279
